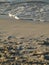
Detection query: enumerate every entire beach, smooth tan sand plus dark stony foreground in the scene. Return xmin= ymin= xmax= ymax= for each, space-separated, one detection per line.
xmin=0 ymin=19 xmax=49 ymax=65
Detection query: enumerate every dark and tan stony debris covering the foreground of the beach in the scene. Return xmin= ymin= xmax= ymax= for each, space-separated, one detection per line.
xmin=0 ymin=36 xmax=49 ymax=65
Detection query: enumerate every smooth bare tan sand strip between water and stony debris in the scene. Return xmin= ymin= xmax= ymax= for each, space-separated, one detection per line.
xmin=0 ymin=19 xmax=49 ymax=37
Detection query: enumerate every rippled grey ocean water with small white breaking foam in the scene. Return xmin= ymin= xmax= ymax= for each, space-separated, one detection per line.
xmin=0 ymin=0 xmax=49 ymax=22
